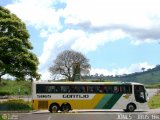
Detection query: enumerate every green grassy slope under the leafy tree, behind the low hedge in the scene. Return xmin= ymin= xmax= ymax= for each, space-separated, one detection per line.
xmin=0 ymin=80 xmax=31 ymax=96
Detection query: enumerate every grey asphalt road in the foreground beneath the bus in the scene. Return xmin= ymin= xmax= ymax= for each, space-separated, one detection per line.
xmin=0 ymin=109 xmax=160 ymax=120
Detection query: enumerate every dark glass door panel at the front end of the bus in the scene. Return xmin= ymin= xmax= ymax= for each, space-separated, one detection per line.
xmin=134 ymin=85 xmax=147 ymax=103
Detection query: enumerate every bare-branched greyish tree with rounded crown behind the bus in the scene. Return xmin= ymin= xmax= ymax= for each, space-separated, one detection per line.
xmin=49 ymin=50 xmax=91 ymax=81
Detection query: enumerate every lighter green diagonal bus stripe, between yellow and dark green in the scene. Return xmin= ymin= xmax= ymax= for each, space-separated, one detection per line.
xmin=95 ymin=94 xmax=113 ymax=109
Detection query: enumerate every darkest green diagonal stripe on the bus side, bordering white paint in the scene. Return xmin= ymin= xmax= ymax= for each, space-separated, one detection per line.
xmin=103 ymin=94 xmax=122 ymax=109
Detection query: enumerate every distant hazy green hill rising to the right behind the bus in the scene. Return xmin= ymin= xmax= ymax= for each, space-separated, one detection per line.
xmin=83 ymin=65 xmax=160 ymax=84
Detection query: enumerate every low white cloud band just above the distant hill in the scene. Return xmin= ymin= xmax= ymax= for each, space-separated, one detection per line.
xmin=90 ymin=62 xmax=155 ymax=76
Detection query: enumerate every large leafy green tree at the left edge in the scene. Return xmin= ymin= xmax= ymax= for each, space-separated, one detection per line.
xmin=0 ymin=6 xmax=40 ymax=82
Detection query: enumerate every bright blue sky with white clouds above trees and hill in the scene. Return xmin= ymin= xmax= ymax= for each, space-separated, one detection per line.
xmin=0 ymin=0 xmax=160 ymax=80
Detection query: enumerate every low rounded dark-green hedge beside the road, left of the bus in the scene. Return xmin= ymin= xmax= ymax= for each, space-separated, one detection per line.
xmin=0 ymin=100 xmax=31 ymax=110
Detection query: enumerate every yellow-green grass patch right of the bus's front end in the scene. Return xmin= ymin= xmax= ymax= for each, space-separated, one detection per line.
xmin=148 ymin=93 xmax=160 ymax=109
